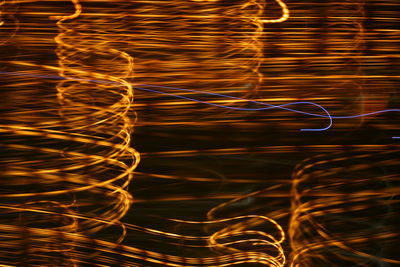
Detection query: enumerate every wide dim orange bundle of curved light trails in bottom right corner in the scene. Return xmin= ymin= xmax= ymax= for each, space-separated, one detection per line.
xmin=289 ymin=151 xmax=400 ymax=267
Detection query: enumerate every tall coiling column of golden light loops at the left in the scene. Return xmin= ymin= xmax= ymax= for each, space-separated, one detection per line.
xmin=54 ymin=0 xmax=139 ymax=237
